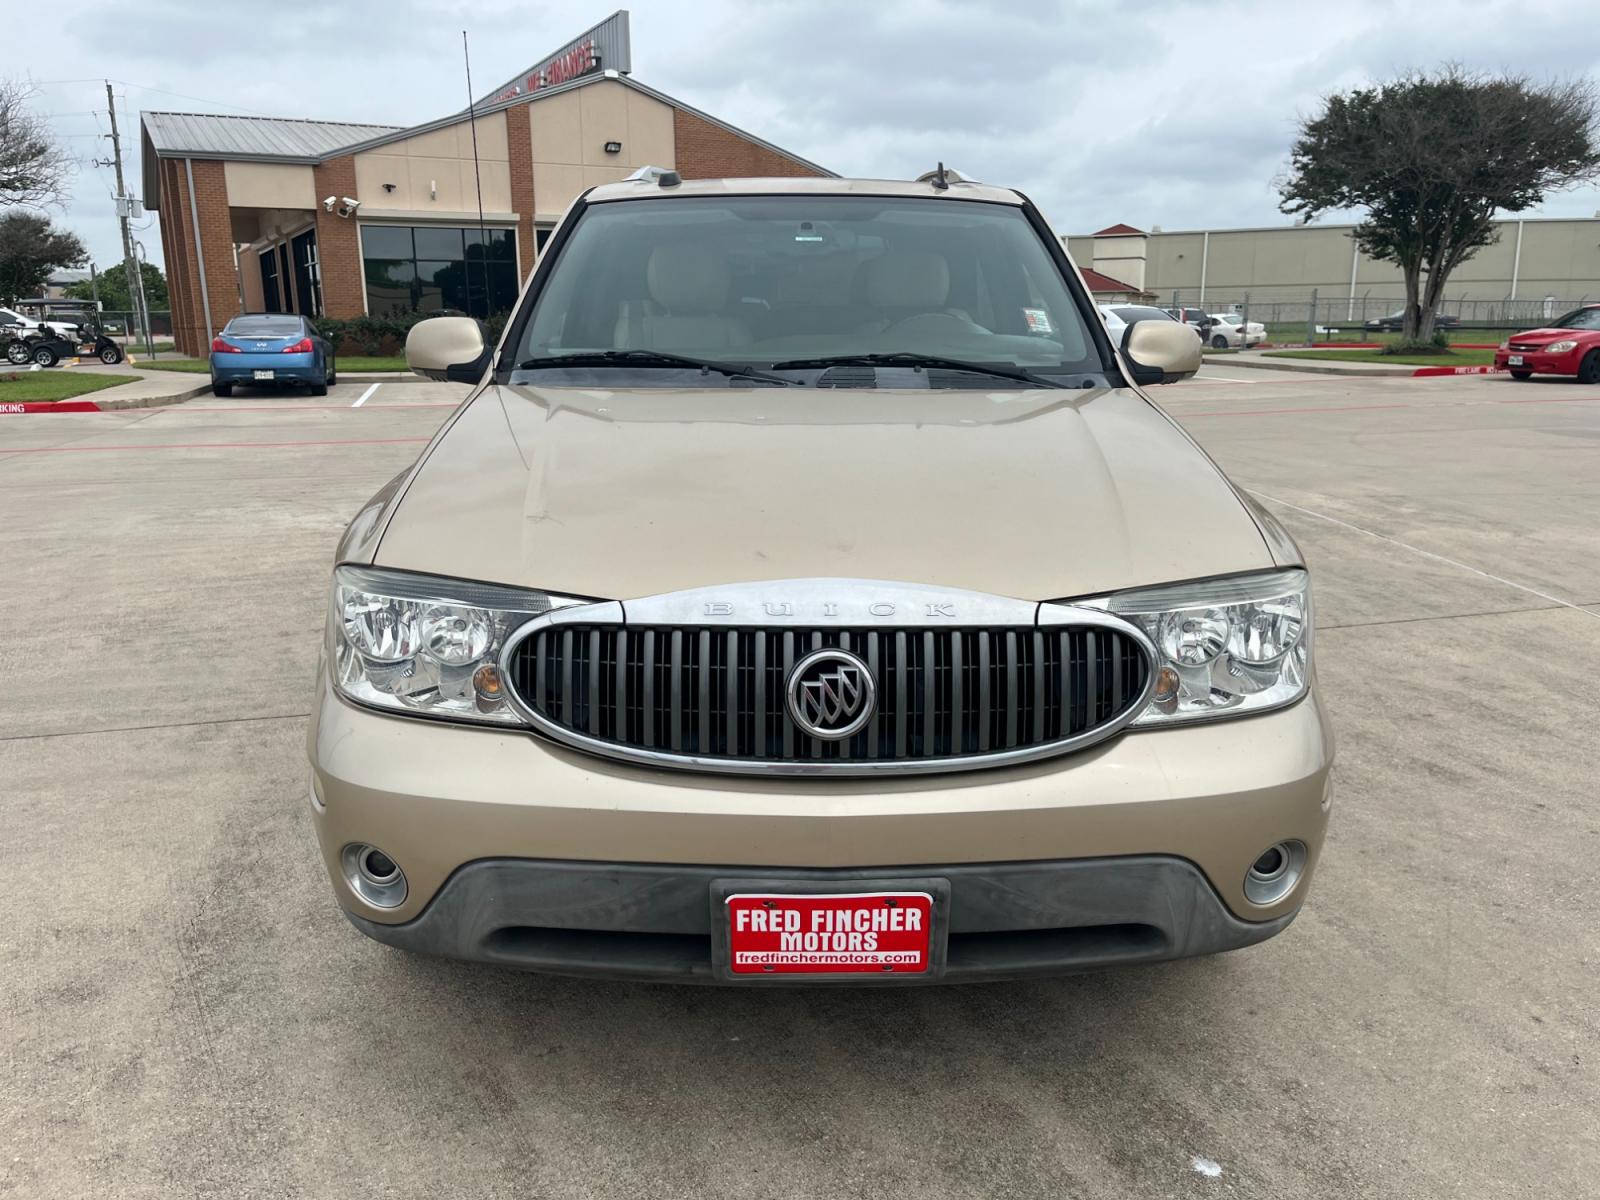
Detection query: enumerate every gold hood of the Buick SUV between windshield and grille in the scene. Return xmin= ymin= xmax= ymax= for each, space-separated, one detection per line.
xmin=374 ymin=386 xmax=1274 ymax=600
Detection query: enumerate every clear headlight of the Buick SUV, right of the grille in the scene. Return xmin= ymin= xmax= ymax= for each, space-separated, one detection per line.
xmin=1106 ymin=570 xmax=1310 ymax=725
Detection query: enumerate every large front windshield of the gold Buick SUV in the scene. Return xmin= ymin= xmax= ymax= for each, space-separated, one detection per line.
xmin=515 ymin=195 xmax=1102 ymax=385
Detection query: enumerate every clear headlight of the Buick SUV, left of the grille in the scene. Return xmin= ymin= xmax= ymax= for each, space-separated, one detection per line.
xmin=328 ymin=566 xmax=584 ymax=725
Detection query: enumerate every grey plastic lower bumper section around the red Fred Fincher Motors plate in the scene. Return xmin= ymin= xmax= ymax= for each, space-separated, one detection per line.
xmin=346 ymin=856 xmax=1294 ymax=986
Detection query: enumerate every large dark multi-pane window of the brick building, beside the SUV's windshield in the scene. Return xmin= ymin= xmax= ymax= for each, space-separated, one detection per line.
xmin=362 ymin=226 xmax=517 ymax=317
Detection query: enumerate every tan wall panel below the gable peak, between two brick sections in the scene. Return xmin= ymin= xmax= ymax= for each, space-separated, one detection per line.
xmin=526 ymin=80 xmax=678 ymax=221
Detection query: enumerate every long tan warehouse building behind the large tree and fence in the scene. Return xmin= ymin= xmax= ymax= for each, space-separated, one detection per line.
xmin=1066 ymin=216 xmax=1600 ymax=320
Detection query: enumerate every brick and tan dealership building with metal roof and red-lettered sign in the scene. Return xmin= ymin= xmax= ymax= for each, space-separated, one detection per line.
xmin=141 ymin=11 xmax=832 ymax=355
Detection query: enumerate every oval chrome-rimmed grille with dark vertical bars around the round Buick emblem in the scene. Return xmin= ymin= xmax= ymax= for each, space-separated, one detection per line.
xmin=504 ymin=622 xmax=1150 ymax=773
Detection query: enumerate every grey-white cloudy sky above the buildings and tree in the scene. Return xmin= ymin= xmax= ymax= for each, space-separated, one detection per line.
xmin=12 ymin=0 xmax=1600 ymax=264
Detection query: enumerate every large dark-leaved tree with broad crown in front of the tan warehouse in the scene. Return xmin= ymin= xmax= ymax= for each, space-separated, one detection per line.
xmin=1278 ymin=66 xmax=1600 ymax=342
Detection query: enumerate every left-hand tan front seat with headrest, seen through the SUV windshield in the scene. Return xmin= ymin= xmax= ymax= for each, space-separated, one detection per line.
xmin=614 ymin=245 xmax=750 ymax=352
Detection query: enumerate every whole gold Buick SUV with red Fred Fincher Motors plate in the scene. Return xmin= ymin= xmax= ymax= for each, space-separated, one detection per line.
xmin=309 ymin=168 xmax=1333 ymax=986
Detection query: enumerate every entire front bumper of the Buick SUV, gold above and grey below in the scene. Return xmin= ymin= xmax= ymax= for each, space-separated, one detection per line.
xmin=309 ymin=675 xmax=1333 ymax=976
